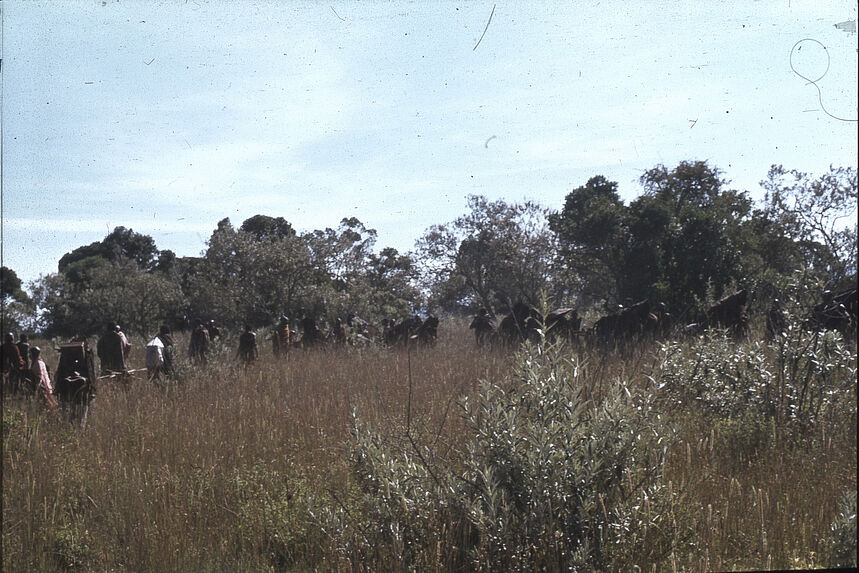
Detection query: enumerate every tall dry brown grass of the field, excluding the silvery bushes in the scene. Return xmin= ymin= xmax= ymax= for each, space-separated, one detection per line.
xmin=2 ymin=322 xmax=857 ymax=571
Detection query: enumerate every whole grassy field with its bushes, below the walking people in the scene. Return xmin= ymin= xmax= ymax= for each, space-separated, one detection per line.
xmin=2 ymin=322 xmax=857 ymax=571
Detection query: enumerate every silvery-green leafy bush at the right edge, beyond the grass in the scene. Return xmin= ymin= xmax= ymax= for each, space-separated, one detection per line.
xmin=652 ymin=320 xmax=856 ymax=424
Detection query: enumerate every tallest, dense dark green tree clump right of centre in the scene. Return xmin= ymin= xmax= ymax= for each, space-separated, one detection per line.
xmin=550 ymin=161 xmax=752 ymax=312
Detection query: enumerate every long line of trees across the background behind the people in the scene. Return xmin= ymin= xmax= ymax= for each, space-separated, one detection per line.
xmin=2 ymin=161 xmax=857 ymax=336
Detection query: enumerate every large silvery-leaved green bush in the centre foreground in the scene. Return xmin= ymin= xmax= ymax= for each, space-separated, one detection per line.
xmin=342 ymin=342 xmax=678 ymax=570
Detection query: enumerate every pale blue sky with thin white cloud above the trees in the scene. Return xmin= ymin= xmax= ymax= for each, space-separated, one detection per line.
xmin=0 ymin=0 xmax=857 ymax=280
